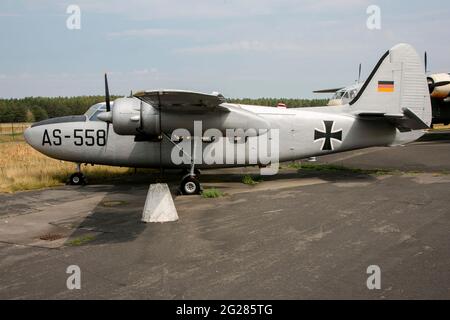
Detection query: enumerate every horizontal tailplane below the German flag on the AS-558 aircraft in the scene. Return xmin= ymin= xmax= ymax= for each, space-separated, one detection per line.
xmin=354 ymin=108 xmax=430 ymax=132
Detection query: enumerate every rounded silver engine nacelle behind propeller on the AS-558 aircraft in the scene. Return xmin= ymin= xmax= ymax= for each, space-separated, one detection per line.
xmin=112 ymin=98 xmax=161 ymax=136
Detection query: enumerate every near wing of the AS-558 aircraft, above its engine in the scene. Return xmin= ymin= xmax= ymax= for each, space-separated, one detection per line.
xmin=134 ymin=89 xmax=229 ymax=112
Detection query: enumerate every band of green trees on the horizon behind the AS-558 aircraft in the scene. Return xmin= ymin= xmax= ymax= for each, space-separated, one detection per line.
xmin=0 ymin=96 xmax=327 ymax=123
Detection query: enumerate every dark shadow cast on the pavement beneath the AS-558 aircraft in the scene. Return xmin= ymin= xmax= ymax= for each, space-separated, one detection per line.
xmin=65 ymin=170 xmax=376 ymax=246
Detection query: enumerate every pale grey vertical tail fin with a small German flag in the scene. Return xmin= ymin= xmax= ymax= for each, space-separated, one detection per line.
xmin=350 ymin=44 xmax=431 ymax=131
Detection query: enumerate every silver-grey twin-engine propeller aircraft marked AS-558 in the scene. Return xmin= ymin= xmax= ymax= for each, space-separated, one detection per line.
xmin=25 ymin=44 xmax=431 ymax=194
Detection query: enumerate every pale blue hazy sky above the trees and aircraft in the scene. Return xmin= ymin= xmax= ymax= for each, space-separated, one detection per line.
xmin=0 ymin=0 xmax=450 ymax=98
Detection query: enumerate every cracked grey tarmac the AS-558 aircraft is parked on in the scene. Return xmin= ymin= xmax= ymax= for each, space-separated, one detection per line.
xmin=0 ymin=140 xmax=450 ymax=299
